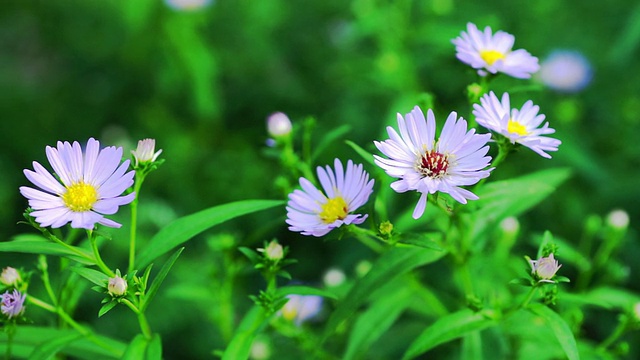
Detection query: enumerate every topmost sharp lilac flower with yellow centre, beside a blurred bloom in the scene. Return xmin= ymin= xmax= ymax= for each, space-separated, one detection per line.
xmin=452 ymin=23 xmax=540 ymax=79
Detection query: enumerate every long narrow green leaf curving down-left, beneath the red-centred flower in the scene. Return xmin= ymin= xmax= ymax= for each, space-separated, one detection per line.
xmin=323 ymin=246 xmax=446 ymax=341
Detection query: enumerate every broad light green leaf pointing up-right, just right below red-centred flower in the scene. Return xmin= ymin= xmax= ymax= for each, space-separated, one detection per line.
xmin=470 ymin=168 xmax=571 ymax=245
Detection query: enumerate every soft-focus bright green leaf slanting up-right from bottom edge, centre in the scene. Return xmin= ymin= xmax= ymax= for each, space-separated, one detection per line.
xmin=343 ymin=282 xmax=413 ymax=360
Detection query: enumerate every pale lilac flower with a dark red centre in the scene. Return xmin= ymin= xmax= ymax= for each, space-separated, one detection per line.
xmin=374 ymin=106 xmax=493 ymax=219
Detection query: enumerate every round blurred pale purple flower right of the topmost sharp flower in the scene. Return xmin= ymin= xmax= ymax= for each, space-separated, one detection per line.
xmin=539 ymin=50 xmax=593 ymax=93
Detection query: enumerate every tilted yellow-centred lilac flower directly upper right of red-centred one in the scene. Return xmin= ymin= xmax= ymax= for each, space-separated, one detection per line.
xmin=473 ymin=91 xmax=562 ymax=159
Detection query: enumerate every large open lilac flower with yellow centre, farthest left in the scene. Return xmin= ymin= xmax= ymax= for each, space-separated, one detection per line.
xmin=20 ymin=138 xmax=135 ymax=230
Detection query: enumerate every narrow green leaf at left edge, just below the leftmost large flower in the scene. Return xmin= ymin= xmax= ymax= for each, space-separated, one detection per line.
xmin=0 ymin=234 xmax=96 ymax=265
